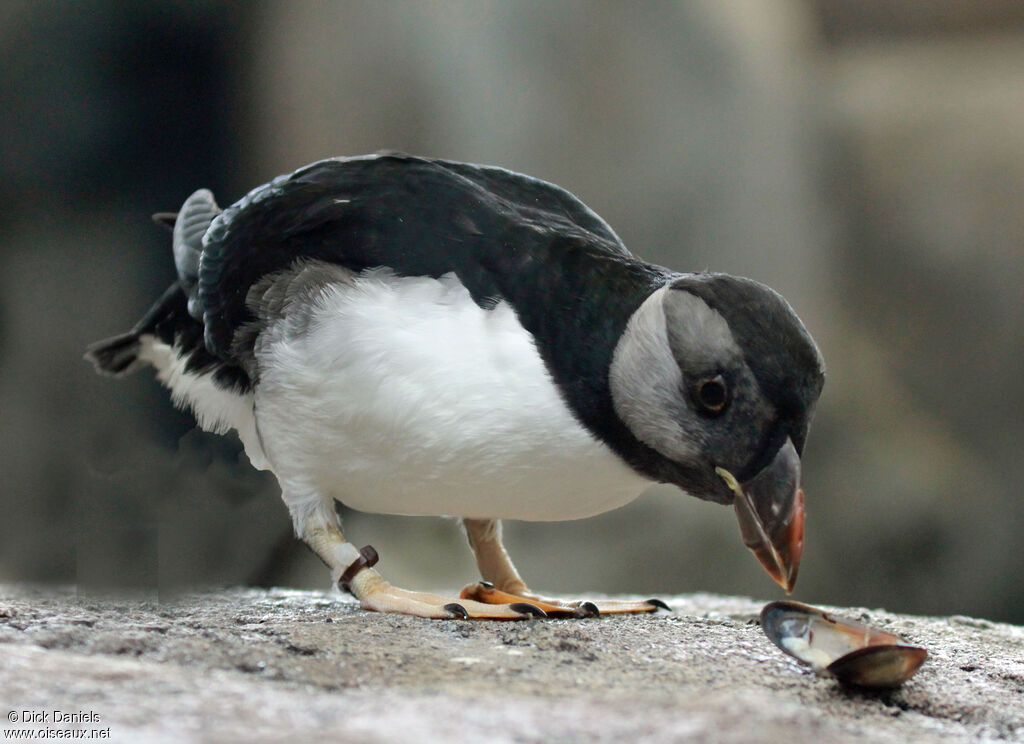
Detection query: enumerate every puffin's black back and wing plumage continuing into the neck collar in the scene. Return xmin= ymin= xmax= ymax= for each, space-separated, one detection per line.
xmin=193 ymin=155 xmax=704 ymax=483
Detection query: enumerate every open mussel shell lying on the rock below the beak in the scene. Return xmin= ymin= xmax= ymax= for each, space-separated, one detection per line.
xmin=761 ymin=600 xmax=928 ymax=688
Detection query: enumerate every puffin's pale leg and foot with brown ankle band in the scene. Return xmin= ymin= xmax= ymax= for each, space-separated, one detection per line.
xmin=290 ymin=500 xmax=544 ymax=620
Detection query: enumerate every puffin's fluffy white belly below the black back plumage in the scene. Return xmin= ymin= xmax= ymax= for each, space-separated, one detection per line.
xmin=249 ymin=271 xmax=650 ymax=520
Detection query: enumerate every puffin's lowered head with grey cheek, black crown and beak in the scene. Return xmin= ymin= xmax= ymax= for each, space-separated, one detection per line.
xmin=610 ymin=274 xmax=824 ymax=592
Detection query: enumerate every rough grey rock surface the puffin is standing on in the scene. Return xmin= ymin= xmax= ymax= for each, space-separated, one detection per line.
xmin=0 ymin=586 xmax=1024 ymax=744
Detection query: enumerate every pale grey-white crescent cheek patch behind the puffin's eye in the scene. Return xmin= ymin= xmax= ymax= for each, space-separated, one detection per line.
xmin=609 ymin=287 xmax=710 ymax=462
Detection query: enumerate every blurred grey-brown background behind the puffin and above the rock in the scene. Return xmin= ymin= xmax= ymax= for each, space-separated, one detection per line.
xmin=0 ymin=0 xmax=1024 ymax=623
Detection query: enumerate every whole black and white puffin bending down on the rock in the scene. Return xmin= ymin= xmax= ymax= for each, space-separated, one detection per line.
xmin=86 ymin=151 xmax=824 ymax=620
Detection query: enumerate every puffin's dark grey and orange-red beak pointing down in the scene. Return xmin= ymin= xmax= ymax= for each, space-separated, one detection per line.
xmin=715 ymin=439 xmax=804 ymax=595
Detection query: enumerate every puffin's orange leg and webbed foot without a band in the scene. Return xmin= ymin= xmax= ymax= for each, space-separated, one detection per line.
xmin=461 ymin=519 xmax=669 ymax=617
